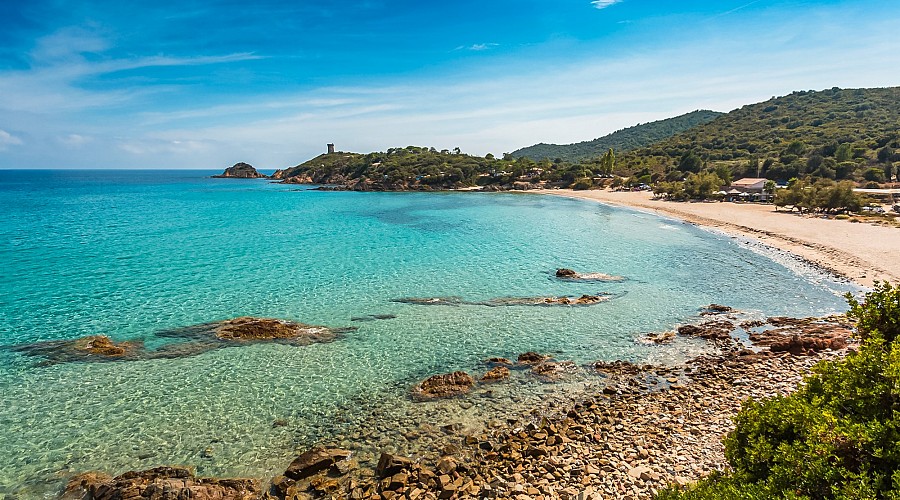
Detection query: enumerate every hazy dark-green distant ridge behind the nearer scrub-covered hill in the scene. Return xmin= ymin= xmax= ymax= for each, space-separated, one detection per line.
xmin=511 ymin=109 xmax=724 ymax=162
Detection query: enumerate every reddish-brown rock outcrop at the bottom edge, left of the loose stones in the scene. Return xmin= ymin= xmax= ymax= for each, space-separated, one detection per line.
xmin=61 ymin=467 xmax=262 ymax=500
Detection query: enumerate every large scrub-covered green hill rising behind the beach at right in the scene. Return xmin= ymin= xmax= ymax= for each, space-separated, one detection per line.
xmin=616 ymin=87 xmax=900 ymax=182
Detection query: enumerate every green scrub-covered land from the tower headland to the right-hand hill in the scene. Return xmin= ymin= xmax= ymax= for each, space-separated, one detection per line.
xmin=273 ymin=87 xmax=900 ymax=201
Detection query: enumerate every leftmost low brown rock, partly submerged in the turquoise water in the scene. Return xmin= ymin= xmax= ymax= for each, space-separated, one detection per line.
xmin=12 ymin=335 xmax=143 ymax=364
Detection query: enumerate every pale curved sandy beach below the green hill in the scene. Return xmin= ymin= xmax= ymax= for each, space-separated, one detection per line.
xmin=538 ymin=189 xmax=900 ymax=287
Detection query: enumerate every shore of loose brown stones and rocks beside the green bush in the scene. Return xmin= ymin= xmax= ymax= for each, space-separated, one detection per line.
xmin=59 ymin=305 xmax=854 ymax=500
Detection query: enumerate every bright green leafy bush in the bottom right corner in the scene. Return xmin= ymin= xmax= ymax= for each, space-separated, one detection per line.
xmin=659 ymin=283 xmax=900 ymax=500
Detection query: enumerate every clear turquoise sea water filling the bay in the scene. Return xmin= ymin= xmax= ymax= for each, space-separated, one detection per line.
xmin=0 ymin=171 xmax=846 ymax=496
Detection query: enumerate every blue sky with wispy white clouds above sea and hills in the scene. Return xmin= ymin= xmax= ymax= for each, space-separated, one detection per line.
xmin=0 ymin=0 xmax=900 ymax=169
